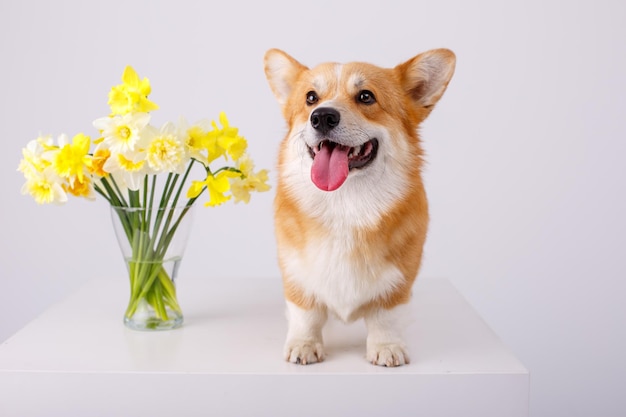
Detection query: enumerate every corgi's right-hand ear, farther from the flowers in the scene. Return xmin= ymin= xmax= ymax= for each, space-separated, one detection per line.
xmin=395 ymin=49 xmax=456 ymax=114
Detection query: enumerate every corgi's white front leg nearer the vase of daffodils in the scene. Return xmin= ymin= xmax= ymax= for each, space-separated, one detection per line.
xmin=285 ymin=301 xmax=327 ymax=365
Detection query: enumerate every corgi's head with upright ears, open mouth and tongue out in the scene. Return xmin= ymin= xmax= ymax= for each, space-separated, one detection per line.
xmin=265 ymin=49 xmax=455 ymax=191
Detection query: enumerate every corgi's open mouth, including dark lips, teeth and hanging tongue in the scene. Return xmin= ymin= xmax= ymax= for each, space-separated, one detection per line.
xmin=309 ymin=139 xmax=378 ymax=191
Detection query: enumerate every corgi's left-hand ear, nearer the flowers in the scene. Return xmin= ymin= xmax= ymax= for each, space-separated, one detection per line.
xmin=265 ymin=49 xmax=308 ymax=106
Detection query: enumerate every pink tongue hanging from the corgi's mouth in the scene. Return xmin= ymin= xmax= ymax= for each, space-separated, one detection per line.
xmin=311 ymin=145 xmax=350 ymax=191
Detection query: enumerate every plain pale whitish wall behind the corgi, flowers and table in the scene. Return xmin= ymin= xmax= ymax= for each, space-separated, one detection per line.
xmin=0 ymin=0 xmax=626 ymax=417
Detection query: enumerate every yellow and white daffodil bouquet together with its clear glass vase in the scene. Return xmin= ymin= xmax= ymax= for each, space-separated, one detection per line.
xmin=18 ymin=66 xmax=270 ymax=329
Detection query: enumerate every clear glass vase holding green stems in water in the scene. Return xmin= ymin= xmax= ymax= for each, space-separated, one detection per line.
xmin=111 ymin=206 xmax=193 ymax=330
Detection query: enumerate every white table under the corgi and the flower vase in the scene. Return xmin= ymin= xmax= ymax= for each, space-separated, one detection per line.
xmin=0 ymin=278 xmax=529 ymax=417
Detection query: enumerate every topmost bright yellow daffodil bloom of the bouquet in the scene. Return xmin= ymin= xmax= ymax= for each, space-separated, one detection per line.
xmin=109 ymin=66 xmax=159 ymax=115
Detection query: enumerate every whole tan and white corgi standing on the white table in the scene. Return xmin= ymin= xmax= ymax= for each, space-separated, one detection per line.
xmin=264 ymin=49 xmax=456 ymax=367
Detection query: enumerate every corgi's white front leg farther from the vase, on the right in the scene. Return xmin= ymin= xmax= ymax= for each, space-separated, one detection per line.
xmin=365 ymin=304 xmax=409 ymax=366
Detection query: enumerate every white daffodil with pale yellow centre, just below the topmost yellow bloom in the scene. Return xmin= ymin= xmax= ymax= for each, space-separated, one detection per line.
xmin=93 ymin=113 xmax=150 ymax=153
